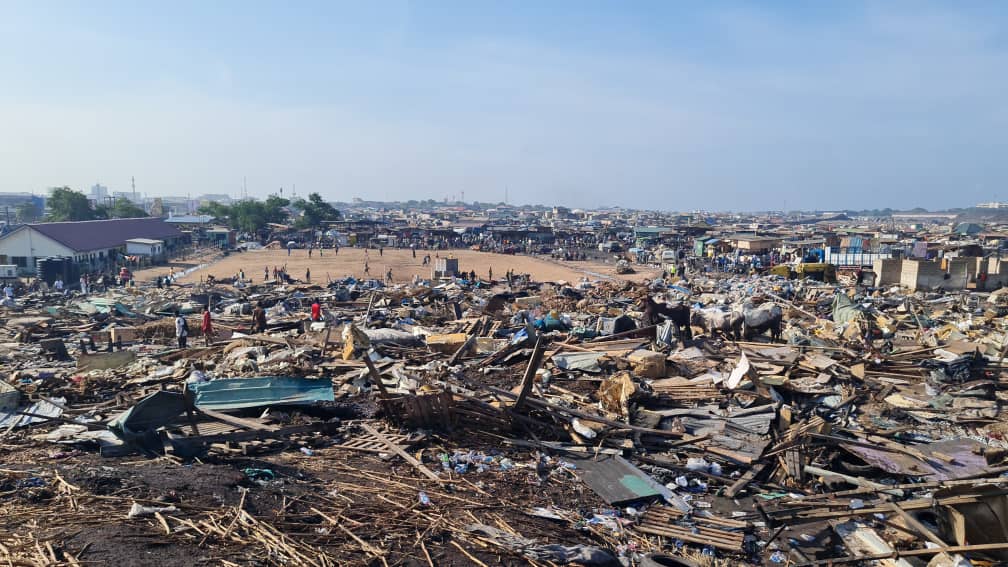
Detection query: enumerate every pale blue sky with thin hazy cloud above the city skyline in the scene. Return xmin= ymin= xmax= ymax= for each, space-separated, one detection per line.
xmin=0 ymin=0 xmax=1008 ymax=210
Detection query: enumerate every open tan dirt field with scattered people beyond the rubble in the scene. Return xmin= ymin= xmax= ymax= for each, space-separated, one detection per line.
xmin=137 ymin=248 xmax=657 ymax=282
